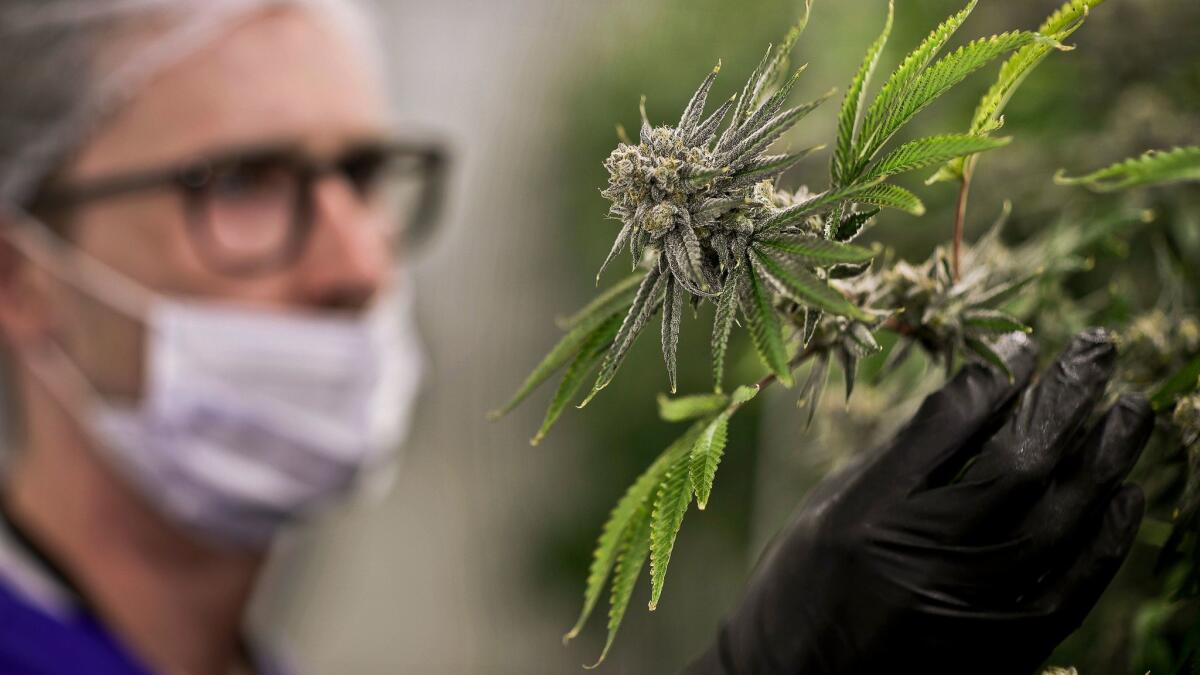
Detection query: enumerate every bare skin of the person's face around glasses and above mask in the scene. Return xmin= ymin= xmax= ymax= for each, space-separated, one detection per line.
xmin=6 ymin=10 xmax=394 ymax=394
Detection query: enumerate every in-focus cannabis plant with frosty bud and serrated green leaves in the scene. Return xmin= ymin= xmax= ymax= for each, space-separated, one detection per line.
xmin=492 ymin=0 xmax=1200 ymax=661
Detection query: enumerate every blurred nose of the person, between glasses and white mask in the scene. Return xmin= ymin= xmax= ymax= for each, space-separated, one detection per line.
xmin=296 ymin=175 xmax=392 ymax=310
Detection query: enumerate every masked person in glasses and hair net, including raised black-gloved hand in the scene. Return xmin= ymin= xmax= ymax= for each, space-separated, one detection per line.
xmin=0 ymin=0 xmax=1152 ymax=675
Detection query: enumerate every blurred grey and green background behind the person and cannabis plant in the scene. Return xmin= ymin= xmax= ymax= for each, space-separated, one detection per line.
xmin=248 ymin=0 xmax=1200 ymax=675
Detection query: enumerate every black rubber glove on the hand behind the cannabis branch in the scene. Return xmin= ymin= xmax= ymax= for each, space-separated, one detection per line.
xmin=688 ymin=330 xmax=1153 ymax=675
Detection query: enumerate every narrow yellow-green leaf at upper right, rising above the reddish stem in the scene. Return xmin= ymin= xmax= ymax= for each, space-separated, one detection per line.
xmin=930 ymin=0 xmax=1104 ymax=183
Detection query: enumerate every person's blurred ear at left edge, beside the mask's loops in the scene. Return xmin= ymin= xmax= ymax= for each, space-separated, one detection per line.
xmin=0 ymin=219 xmax=53 ymax=350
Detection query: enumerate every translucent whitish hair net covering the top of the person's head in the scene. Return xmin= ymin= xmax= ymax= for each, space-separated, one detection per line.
xmin=0 ymin=0 xmax=379 ymax=207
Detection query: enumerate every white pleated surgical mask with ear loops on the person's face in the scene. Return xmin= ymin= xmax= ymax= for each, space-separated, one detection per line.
xmin=3 ymin=210 xmax=424 ymax=548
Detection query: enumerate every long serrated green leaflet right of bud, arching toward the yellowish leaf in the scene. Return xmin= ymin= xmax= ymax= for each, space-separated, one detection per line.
xmin=859 ymin=31 xmax=1038 ymax=163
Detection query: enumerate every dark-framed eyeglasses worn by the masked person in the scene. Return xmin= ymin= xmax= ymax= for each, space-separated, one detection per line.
xmin=31 ymin=142 xmax=446 ymax=276
